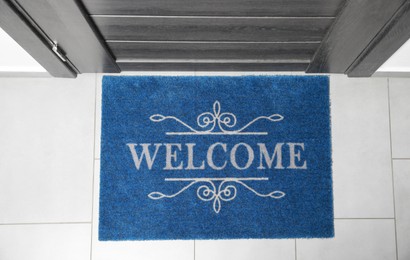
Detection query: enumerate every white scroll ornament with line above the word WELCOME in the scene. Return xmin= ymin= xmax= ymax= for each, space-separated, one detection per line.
xmin=150 ymin=101 xmax=283 ymax=135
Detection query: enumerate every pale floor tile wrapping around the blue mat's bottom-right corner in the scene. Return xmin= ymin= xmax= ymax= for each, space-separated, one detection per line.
xmin=297 ymin=219 xmax=396 ymax=260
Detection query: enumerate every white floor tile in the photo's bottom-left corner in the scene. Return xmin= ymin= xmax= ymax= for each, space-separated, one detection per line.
xmin=0 ymin=224 xmax=91 ymax=260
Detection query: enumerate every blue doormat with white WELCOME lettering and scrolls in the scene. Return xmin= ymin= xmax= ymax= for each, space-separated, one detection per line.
xmin=99 ymin=76 xmax=334 ymax=241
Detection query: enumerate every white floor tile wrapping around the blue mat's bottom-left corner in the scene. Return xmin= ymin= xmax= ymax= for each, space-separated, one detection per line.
xmin=92 ymin=160 xmax=194 ymax=260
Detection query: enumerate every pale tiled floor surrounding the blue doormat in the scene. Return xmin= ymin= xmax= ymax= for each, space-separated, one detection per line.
xmin=0 ymin=73 xmax=410 ymax=260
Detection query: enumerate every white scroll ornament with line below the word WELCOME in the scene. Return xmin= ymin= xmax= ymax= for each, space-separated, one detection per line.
xmin=148 ymin=178 xmax=285 ymax=213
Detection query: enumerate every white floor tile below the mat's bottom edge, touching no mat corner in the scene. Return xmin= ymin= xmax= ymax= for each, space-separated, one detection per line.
xmin=195 ymin=239 xmax=295 ymax=260
